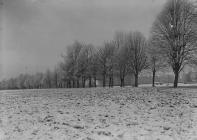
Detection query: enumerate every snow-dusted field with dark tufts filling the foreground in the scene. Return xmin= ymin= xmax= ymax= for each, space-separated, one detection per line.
xmin=0 ymin=87 xmax=197 ymax=140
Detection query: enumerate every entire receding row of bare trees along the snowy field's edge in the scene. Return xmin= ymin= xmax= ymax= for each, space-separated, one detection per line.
xmin=0 ymin=0 xmax=197 ymax=89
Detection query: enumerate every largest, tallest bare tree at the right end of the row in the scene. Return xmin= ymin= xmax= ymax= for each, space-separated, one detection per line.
xmin=152 ymin=0 xmax=197 ymax=88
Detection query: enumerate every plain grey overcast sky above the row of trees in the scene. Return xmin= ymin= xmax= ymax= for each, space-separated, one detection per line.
xmin=0 ymin=0 xmax=165 ymax=79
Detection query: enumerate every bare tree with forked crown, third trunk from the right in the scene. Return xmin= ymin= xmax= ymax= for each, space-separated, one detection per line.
xmin=127 ymin=32 xmax=148 ymax=87
